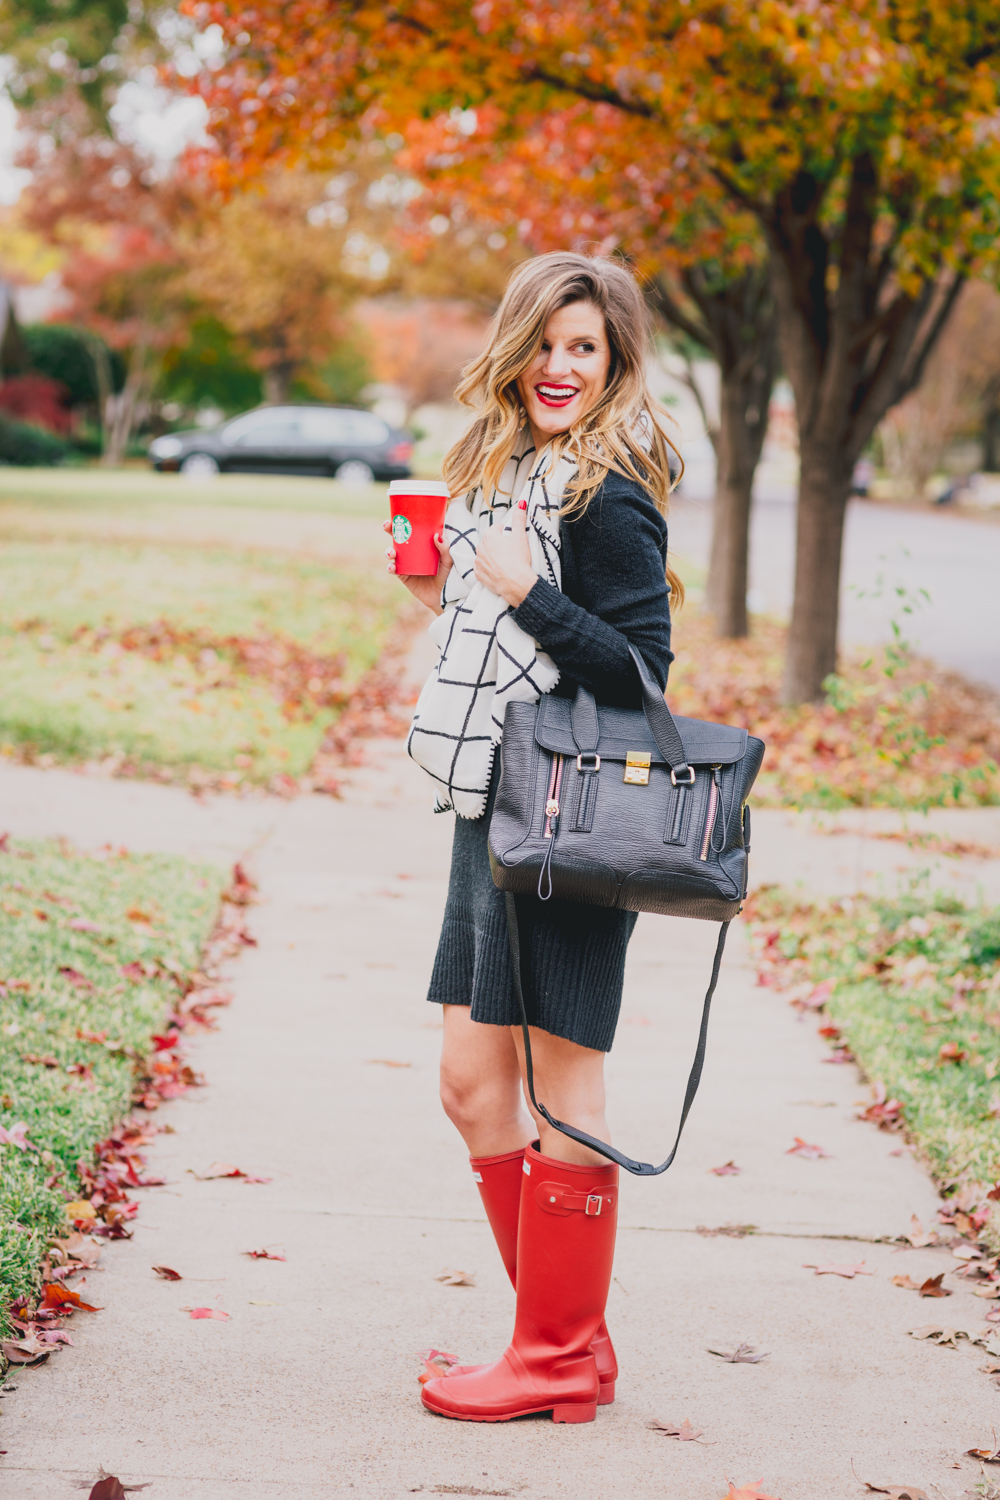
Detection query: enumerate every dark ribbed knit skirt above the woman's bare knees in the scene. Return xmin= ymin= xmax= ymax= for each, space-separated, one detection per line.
xmin=427 ymin=773 xmax=636 ymax=1052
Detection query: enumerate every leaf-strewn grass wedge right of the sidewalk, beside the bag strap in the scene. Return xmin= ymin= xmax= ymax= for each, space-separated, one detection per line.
xmin=747 ymin=882 xmax=1000 ymax=1251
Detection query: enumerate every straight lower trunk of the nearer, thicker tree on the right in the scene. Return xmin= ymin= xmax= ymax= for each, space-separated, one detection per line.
xmin=783 ymin=434 xmax=853 ymax=704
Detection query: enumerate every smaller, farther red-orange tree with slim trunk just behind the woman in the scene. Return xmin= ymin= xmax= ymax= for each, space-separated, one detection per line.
xmin=399 ymin=104 xmax=778 ymax=638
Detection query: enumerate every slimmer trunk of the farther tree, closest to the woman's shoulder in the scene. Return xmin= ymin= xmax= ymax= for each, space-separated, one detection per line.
xmin=705 ymin=360 xmax=772 ymax=639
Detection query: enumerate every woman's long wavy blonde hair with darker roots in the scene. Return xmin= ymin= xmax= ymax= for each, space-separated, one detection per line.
xmin=444 ymin=251 xmax=684 ymax=605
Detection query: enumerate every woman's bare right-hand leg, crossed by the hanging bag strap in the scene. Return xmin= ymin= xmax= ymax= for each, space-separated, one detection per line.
xmin=510 ymin=1026 xmax=610 ymax=1167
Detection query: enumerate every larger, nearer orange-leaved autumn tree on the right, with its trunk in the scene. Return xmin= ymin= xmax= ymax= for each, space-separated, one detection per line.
xmin=187 ymin=0 xmax=1000 ymax=702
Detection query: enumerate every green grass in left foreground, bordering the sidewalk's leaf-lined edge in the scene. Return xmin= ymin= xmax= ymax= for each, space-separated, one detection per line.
xmin=0 ymin=843 xmax=225 ymax=1328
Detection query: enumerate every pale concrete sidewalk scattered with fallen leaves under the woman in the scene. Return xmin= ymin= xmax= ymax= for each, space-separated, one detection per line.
xmin=0 ymin=756 xmax=1000 ymax=1500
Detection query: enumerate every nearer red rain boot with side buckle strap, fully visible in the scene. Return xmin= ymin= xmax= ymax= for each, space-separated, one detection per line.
xmin=423 ymin=1146 xmax=618 ymax=1422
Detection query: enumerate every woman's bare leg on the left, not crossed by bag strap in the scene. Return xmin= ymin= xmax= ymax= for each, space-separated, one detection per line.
xmin=441 ymin=1005 xmax=530 ymax=1157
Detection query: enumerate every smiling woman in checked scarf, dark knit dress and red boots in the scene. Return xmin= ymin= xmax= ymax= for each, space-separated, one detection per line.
xmin=385 ymin=252 xmax=682 ymax=1422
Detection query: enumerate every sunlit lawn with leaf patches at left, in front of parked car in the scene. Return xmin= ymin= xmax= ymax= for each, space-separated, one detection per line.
xmin=0 ymin=470 xmax=406 ymax=786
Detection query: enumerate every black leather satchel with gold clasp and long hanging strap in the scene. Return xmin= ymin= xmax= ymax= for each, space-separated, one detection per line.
xmin=489 ymin=647 xmax=765 ymax=1178
